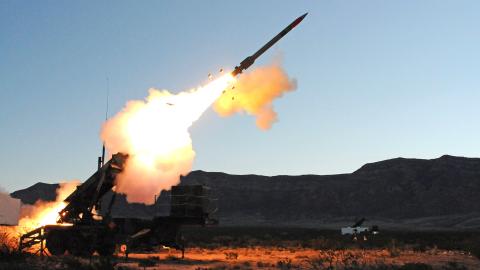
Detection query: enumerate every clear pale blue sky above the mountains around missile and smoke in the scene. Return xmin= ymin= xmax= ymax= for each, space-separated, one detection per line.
xmin=0 ymin=0 xmax=480 ymax=191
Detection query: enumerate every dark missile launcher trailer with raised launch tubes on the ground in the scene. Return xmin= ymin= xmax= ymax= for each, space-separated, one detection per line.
xmin=19 ymin=153 xmax=218 ymax=257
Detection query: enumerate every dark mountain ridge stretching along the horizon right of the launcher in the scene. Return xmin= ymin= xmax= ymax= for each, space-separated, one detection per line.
xmin=10 ymin=156 xmax=480 ymax=229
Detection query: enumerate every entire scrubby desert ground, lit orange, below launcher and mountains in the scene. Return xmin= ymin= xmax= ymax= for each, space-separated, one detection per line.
xmin=0 ymin=228 xmax=480 ymax=270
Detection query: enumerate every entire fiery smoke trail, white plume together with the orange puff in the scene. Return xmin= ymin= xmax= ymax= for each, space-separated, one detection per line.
xmin=101 ymin=64 xmax=296 ymax=204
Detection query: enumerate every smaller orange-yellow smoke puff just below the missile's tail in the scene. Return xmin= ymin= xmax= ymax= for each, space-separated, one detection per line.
xmin=214 ymin=63 xmax=297 ymax=130
